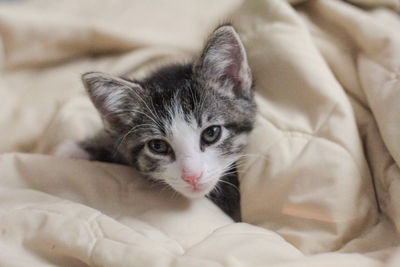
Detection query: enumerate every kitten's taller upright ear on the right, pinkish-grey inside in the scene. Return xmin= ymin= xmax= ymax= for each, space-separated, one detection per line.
xmin=194 ymin=25 xmax=253 ymax=97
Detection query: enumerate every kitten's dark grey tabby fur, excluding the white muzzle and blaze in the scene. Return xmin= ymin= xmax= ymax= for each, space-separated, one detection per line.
xmin=76 ymin=25 xmax=256 ymax=221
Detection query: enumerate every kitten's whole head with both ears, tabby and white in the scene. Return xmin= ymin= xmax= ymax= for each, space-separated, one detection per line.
xmin=82 ymin=25 xmax=256 ymax=197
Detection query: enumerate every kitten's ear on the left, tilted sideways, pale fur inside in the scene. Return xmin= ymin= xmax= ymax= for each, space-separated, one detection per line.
xmin=82 ymin=72 xmax=142 ymax=131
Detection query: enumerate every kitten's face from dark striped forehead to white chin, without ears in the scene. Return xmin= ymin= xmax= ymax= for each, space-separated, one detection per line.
xmin=131 ymin=84 xmax=254 ymax=197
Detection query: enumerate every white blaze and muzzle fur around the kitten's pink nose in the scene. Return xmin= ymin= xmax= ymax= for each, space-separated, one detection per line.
xmin=149 ymin=104 xmax=237 ymax=198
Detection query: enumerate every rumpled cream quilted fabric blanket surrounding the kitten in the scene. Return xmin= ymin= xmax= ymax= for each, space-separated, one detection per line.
xmin=0 ymin=0 xmax=400 ymax=267
